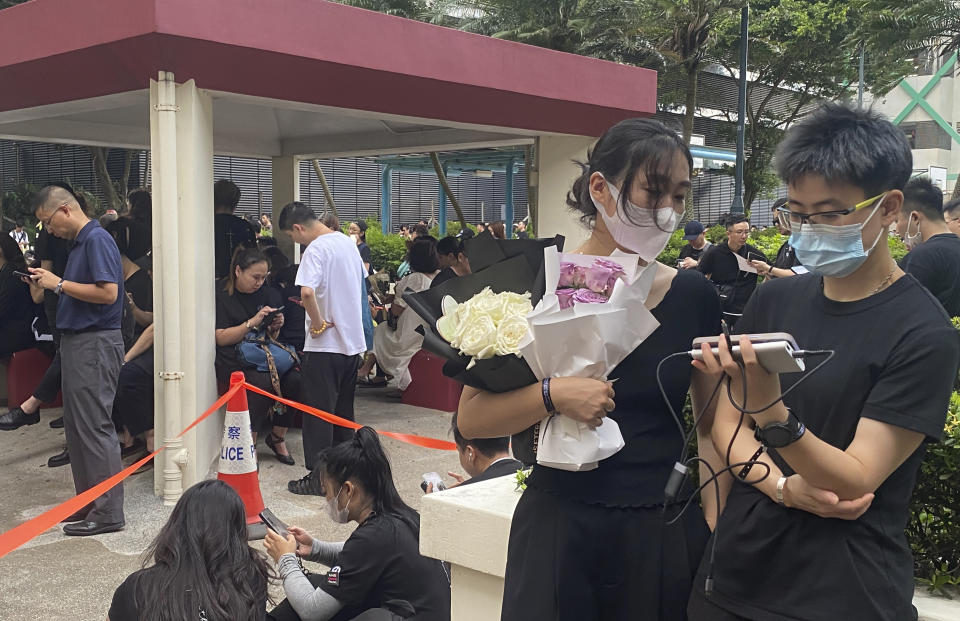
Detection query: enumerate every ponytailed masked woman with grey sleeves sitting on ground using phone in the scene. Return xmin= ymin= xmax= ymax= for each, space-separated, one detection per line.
xmin=264 ymin=427 xmax=450 ymax=621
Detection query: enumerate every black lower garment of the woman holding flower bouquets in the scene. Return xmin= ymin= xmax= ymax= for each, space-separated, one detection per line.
xmin=501 ymin=487 xmax=708 ymax=621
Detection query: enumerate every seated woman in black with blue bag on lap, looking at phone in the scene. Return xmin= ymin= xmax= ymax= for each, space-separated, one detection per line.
xmin=216 ymin=248 xmax=300 ymax=465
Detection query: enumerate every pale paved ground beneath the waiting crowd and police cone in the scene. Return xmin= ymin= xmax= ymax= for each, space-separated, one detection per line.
xmin=0 ymin=390 xmax=460 ymax=621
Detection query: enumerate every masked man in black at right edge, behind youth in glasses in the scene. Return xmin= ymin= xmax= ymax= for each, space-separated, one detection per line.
xmin=897 ymin=177 xmax=960 ymax=317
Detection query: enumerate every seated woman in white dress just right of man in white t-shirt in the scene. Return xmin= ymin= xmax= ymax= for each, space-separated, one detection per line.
xmin=357 ymin=235 xmax=440 ymax=390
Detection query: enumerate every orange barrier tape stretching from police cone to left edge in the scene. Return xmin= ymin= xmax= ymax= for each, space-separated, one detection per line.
xmin=0 ymin=384 xmax=243 ymax=558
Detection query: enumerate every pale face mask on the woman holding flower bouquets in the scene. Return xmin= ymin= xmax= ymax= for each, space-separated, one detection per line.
xmin=591 ymin=174 xmax=680 ymax=263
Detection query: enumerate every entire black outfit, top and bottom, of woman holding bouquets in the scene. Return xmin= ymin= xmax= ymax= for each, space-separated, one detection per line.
xmin=502 ymin=270 xmax=720 ymax=621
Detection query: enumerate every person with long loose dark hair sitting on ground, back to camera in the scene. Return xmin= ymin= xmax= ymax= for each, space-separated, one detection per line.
xmin=107 ymin=480 xmax=272 ymax=621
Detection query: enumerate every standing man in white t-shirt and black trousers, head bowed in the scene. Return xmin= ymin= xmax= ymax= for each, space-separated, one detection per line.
xmin=278 ymin=202 xmax=367 ymax=494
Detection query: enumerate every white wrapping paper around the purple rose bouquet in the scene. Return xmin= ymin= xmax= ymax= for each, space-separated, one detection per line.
xmin=520 ymin=247 xmax=660 ymax=471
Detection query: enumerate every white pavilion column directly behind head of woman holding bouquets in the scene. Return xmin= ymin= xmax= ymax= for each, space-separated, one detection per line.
xmin=536 ymin=136 xmax=596 ymax=251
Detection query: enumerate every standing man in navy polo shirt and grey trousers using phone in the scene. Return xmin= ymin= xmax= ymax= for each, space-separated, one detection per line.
xmin=30 ymin=186 xmax=124 ymax=536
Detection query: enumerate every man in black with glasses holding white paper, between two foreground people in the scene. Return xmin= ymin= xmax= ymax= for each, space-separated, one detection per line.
xmin=697 ymin=214 xmax=765 ymax=326
